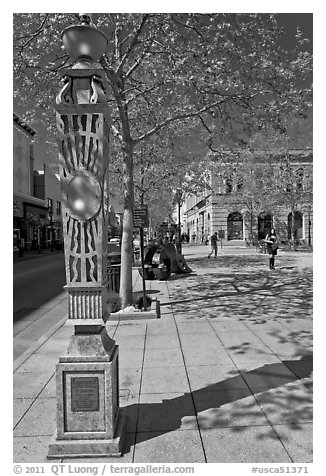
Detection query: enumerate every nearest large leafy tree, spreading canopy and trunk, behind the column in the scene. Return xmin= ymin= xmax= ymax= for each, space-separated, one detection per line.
xmin=14 ymin=13 xmax=312 ymax=306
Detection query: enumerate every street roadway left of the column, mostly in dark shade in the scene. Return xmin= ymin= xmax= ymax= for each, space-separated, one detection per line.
xmin=13 ymin=253 xmax=66 ymax=359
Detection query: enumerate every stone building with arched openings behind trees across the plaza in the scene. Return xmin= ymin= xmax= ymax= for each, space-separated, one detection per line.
xmin=183 ymin=150 xmax=313 ymax=246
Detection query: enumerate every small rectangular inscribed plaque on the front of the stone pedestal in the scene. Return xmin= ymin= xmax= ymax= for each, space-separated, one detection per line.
xmin=71 ymin=377 xmax=100 ymax=412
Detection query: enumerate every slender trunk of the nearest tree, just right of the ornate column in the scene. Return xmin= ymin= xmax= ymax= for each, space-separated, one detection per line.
xmin=120 ymin=140 xmax=134 ymax=309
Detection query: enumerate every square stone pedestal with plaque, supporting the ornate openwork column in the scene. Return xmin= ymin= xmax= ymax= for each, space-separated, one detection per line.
xmin=48 ymin=321 xmax=125 ymax=459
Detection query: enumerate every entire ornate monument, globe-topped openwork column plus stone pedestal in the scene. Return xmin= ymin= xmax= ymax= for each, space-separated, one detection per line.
xmin=48 ymin=15 xmax=123 ymax=458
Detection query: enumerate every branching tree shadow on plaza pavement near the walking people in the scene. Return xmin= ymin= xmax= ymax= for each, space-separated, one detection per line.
xmin=166 ymin=256 xmax=313 ymax=321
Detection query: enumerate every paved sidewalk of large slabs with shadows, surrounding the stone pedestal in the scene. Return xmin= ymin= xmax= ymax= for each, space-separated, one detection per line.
xmin=14 ymin=247 xmax=312 ymax=463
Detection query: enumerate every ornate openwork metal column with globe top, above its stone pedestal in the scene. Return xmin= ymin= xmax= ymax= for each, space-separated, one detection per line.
xmin=56 ymin=18 xmax=110 ymax=324
